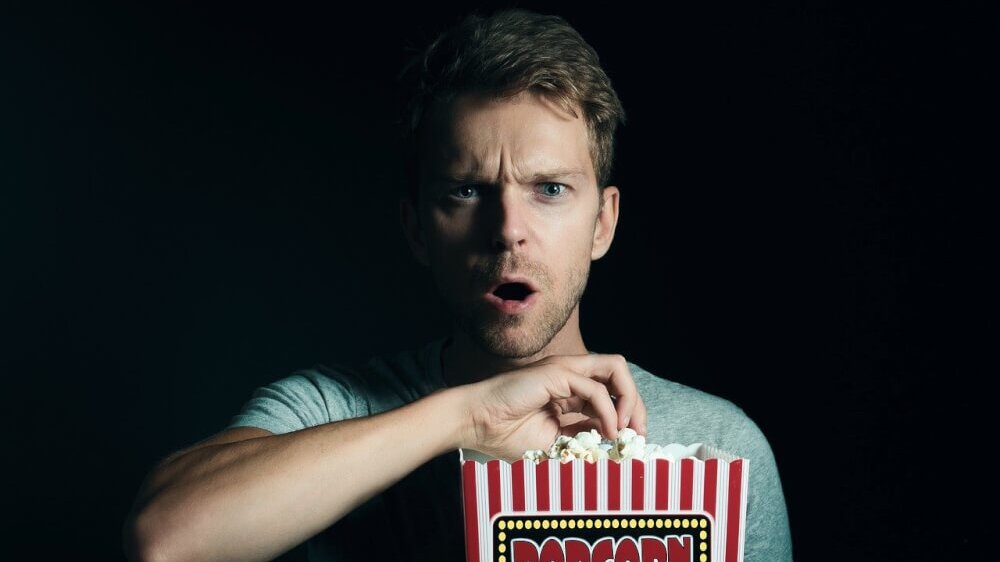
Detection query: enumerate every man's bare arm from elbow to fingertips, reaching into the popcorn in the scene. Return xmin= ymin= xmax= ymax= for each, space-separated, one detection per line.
xmin=123 ymin=355 xmax=646 ymax=562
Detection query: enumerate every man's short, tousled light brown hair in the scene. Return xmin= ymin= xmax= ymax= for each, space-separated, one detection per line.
xmin=400 ymin=9 xmax=625 ymax=202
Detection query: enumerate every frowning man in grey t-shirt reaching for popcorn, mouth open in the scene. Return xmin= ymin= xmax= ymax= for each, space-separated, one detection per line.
xmin=125 ymin=11 xmax=791 ymax=561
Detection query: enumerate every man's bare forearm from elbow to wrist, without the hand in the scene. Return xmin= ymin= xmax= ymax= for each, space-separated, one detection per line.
xmin=133 ymin=387 xmax=466 ymax=560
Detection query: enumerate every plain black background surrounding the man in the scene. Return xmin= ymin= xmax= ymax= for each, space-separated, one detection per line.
xmin=0 ymin=2 xmax=995 ymax=560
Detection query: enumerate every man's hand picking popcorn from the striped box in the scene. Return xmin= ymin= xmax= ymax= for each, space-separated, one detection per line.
xmin=463 ymin=354 xmax=646 ymax=460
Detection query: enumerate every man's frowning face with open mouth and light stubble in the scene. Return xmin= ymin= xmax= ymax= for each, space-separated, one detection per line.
xmin=404 ymin=93 xmax=617 ymax=358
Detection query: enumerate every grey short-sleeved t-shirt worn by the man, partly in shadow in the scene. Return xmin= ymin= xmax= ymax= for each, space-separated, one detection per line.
xmin=229 ymin=338 xmax=792 ymax=562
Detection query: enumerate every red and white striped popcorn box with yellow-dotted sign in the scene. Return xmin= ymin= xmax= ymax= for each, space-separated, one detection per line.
xmin=460 ymin=445 xmax=749 ymax=562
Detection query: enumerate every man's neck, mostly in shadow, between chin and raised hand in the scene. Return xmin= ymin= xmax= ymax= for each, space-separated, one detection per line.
xmin=441 ymin=304 xmax=589 ymax=387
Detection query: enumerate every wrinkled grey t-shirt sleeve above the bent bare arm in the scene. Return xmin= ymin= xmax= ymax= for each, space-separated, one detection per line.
xmin=226 ymin=370 xmax=364 ymax=434
